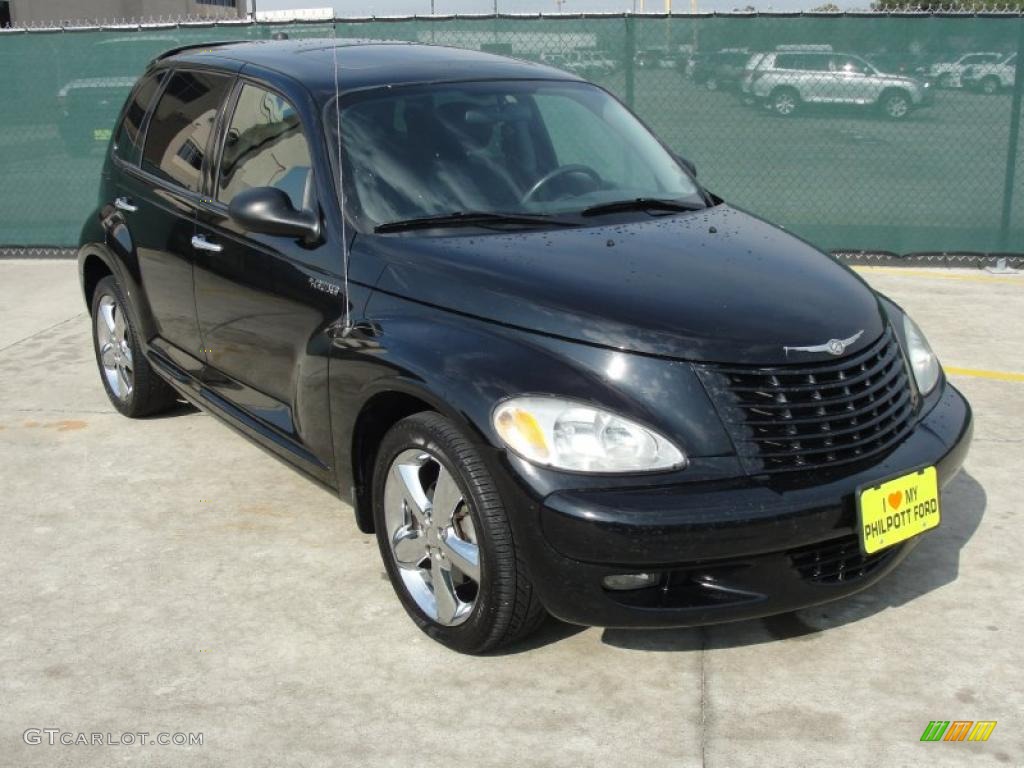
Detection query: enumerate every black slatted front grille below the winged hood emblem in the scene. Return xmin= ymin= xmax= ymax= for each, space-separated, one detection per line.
xmin=695 ymin=329 xmax=916 ymax=474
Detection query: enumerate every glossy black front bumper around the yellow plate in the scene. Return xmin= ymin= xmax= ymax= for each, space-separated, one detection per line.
xmin=503 ymin=383 xmax=973 ymax=627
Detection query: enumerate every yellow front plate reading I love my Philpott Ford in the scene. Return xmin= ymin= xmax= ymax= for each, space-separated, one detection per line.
xmin=858 ymin=467 xmax=940 ymax=554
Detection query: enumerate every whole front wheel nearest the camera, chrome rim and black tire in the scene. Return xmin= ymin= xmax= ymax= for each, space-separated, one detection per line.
xmin=373 ymin=413 xmax=545 ymax=653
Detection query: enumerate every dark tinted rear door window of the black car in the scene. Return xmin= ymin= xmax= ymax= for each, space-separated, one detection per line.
xmin=142 ymin=72 xmax=231 ymax=191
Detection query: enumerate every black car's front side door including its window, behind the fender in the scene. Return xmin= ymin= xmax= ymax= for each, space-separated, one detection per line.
xmin=196 ymin=73 xmax=344 ymax=479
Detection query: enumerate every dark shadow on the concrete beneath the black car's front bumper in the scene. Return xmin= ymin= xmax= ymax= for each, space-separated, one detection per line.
xmin=601 ymin=472 xmax=987 ymax=651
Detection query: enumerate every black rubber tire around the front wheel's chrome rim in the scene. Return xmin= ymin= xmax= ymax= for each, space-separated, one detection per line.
xmin=373 ymin=412 xmax=547 ymax=653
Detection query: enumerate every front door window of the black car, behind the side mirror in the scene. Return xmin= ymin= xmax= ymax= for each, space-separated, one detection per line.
xmin=223 ymin=85 xmax=312 ymax=210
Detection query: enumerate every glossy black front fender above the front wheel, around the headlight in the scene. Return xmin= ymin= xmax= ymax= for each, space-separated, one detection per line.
xmin=331 ymin=292 xmax=736 ymax=528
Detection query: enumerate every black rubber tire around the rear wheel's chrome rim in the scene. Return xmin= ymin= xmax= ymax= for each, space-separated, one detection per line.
xmin=90 ymin=275 xmax=177 ymax=419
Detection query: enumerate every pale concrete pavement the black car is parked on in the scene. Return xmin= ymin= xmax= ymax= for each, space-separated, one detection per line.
xmin=0 ymin=261 xmax=1024 ymax=768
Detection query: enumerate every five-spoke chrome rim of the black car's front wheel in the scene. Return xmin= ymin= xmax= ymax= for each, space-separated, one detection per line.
xmin=384 ymin=449 xmax=480 ymax=627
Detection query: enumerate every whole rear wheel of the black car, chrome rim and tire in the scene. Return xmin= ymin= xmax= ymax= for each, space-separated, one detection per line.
xmin=92 ymin=276 xmax=177 ymax=418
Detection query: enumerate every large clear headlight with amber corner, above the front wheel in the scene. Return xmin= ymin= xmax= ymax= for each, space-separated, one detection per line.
xmin=493 ymin=396 xmax=686 ymax=472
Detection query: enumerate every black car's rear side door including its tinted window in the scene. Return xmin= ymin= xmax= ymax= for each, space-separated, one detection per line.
xmin=115 ymin=71 xmax=232 ymax=371
